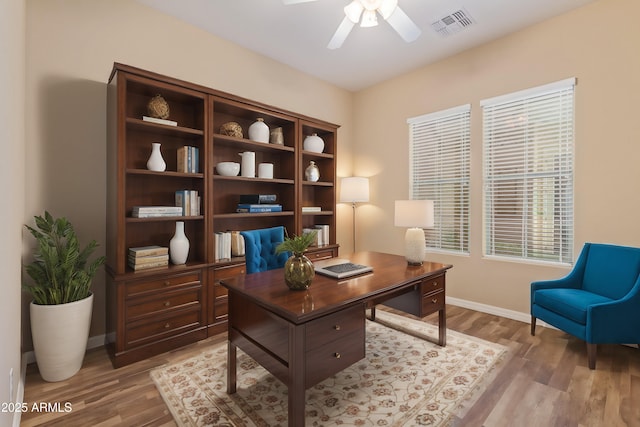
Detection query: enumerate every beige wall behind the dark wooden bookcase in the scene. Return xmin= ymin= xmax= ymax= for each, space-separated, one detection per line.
xmin=25 ymin=0 xmax=352 ymax=346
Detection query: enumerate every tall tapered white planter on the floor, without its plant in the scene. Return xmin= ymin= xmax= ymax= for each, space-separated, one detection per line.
xmin=30 ymin=294 xmax=93 ymax=382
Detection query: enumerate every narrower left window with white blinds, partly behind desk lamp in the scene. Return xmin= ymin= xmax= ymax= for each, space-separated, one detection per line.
xmin=407 ymin=105 xmax=471 ymax=253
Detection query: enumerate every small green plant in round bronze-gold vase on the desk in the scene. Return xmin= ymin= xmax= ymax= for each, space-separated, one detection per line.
xmin=276 ymin=230 xmax=318 ymax=290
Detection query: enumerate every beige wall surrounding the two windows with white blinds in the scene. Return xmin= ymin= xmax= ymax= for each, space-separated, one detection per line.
xmin=353 ymin=0 xmax=640 ymax=313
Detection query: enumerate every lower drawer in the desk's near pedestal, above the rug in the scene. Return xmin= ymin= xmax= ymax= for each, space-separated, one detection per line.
xmin=305 ymin=327 xmax=365 ymax=388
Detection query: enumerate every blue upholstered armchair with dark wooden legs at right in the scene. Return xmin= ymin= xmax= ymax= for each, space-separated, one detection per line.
xmin=531 ymin=243 xmax=640 ymax=369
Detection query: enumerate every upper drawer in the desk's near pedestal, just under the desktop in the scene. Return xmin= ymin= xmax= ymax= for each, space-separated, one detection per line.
xmin=305 ymin=305 xmax=365 ymax=352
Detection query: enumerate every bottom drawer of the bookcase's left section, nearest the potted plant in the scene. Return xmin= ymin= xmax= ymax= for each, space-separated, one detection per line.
xmin=125 ymin=307 xmax=202 ymax=348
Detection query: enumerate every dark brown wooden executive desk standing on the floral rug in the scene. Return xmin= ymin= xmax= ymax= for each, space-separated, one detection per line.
xmin=221 ymin=252 xmax=452 ymax=427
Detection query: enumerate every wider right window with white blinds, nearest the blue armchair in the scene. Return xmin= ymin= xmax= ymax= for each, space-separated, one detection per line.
xmin=480 ymin=79 xmax=575 ymax=264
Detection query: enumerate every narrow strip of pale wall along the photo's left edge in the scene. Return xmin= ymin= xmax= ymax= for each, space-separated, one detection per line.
xmin=0 ymin=0 xmax=25 ymax=418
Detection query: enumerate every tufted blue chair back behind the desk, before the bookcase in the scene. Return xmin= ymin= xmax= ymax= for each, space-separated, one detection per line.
xmin=240 ymin=227 xmax=289 ymax=274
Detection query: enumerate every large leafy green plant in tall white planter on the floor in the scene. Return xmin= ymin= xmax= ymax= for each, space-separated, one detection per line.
xmin=23 ymin=211 xmax=105 ymax=381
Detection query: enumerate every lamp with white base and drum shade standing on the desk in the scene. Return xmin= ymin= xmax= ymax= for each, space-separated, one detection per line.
xmin=395 ymin=200 xmax=433 ymax=265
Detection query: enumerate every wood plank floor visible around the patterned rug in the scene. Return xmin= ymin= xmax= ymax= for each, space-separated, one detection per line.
xmin=21 ymin=306 xmax=640 ymax=427
